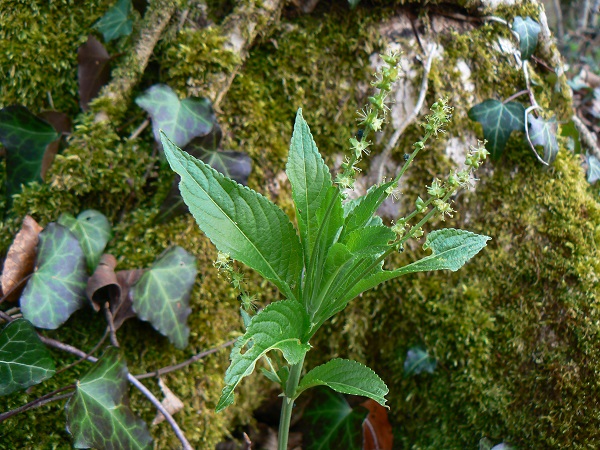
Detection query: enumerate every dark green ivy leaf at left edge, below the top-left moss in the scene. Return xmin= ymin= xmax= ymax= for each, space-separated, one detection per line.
xmin=0 ymin=105 xmax=60 ymax=199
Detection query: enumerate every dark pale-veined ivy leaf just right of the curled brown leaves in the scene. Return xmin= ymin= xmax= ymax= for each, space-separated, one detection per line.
xmin=131 ymin=246 xmax=197 ymax=349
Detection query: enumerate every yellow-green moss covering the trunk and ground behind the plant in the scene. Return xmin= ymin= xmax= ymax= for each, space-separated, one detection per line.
xmin=0 ymin=2 xmax=600 ymax=449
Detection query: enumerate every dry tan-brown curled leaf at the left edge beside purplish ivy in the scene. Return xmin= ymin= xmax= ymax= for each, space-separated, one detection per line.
xmin=1 ymin=216 xmax=43 ymax=302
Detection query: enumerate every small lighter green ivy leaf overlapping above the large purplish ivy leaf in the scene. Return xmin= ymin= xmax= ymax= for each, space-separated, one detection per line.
xmin=58 ymin=209 xmax=112 ymax=273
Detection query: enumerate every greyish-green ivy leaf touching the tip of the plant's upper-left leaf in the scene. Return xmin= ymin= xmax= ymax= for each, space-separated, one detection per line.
xmin=135 ymin=84 xmax=215 ymax=151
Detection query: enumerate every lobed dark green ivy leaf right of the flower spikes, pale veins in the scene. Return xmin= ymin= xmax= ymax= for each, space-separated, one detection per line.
xmin=469 ymin=99 xmax=525 ymax=159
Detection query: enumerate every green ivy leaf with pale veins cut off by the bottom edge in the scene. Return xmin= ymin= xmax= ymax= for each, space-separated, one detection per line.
xmin=65 ymin=347 xmax=152 ymax=450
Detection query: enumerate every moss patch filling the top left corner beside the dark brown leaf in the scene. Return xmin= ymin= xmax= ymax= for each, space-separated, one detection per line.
xmin=0 ymin=0 xmax=111 ymax=114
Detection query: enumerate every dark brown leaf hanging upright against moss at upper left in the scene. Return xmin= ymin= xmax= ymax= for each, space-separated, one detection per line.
xmin=77 ymin=34 xmax=110 ymax=111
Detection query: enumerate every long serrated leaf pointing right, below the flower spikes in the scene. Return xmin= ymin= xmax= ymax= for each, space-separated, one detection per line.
xmin=340 ymin=228 xmax=491 ymax=302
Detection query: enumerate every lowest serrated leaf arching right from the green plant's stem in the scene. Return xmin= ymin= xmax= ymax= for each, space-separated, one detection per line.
xmin=296 ymin=358 xmax=389 ymax=406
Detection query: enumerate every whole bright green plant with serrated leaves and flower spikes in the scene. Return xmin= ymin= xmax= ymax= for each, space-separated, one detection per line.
xmin=161 ymin=54 xmax=490 ymax=450
